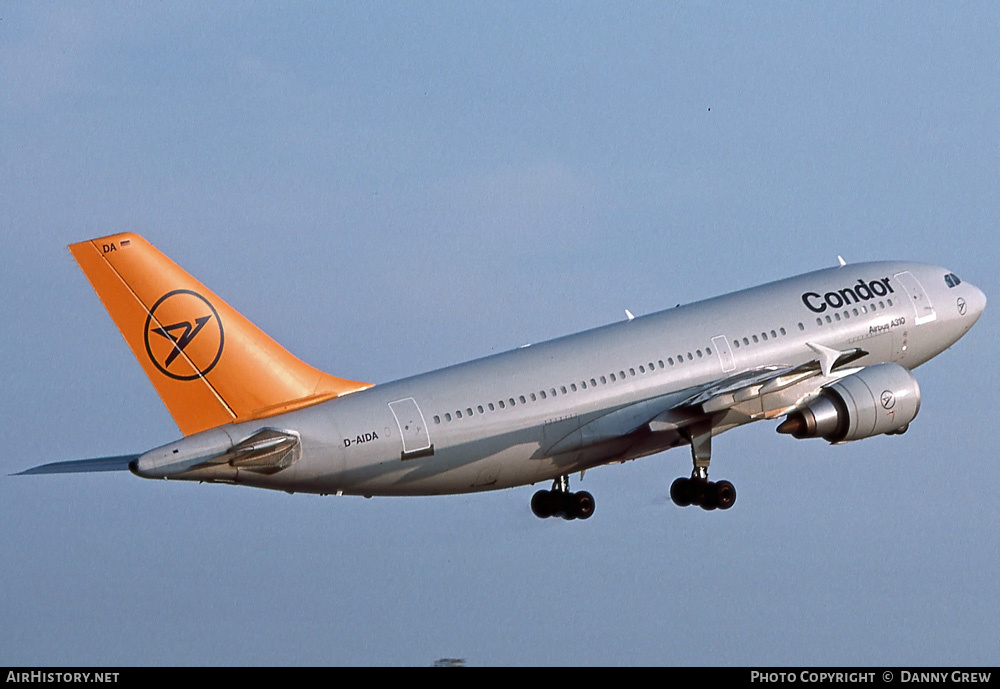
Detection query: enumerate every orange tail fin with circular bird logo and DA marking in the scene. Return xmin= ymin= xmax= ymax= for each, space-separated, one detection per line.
xmin=69 ymin=233 xmax=371 ymax=435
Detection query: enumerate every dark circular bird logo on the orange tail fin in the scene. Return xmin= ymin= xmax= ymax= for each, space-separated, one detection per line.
xmin=144 ymin=289 xmax=225 ymax=380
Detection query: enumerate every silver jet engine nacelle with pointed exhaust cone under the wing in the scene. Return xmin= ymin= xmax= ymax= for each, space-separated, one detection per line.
xmin=778 ymin=364 xmax=920 ymax=443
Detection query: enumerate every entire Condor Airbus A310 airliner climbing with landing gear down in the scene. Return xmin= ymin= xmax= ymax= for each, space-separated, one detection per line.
xmin=21 ymin=233 xmax=986 ymax=520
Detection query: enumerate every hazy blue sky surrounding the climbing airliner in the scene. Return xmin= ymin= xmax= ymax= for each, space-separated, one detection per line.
xmin=0 ymin=2 xmax=1000 ymax=665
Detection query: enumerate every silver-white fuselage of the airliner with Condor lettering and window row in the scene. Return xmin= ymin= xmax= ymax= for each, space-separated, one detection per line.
xmin=135 ymin=262 xmax=986 ymax=495
